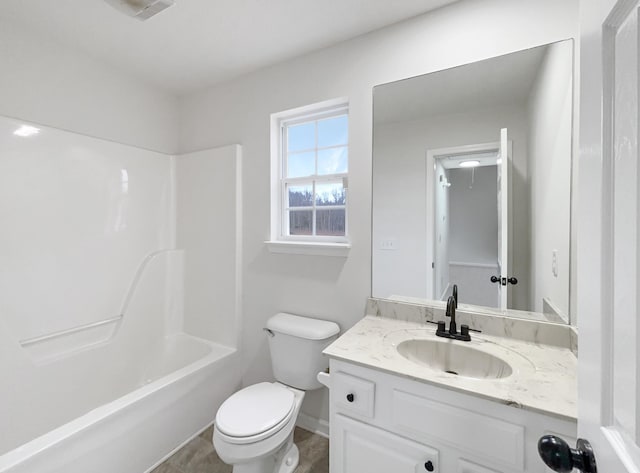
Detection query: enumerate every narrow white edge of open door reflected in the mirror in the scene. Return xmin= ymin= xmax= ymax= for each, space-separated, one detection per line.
xmin=498 ymin=128 xmax=510 ymax=310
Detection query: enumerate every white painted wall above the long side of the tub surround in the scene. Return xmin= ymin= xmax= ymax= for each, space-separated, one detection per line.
xmin=0 ymin=18 xmax=177 ymax=153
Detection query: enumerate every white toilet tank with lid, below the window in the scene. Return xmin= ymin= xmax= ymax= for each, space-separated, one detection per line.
xmin=267 ymin=313 xmax=340 ymax=391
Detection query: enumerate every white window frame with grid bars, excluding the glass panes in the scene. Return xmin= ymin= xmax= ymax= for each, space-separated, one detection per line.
xmin=271 ymin=99 xmax=350 ymax=246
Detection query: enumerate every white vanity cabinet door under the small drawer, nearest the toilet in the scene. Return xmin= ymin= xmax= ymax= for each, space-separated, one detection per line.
xmin=330 ymin=414 xmax=440 ymax=473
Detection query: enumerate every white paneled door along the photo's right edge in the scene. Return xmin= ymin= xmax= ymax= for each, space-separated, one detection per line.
xmin=577 ymin=0 xmax=640 ymax=473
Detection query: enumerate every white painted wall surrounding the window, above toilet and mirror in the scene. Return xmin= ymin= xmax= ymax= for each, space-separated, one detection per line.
xmin=179 ymin=0 xmax=578 ymax=424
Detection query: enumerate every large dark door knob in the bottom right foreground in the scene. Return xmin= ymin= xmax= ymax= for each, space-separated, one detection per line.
xmin=538 ymin=435 xmax=598 ymax=473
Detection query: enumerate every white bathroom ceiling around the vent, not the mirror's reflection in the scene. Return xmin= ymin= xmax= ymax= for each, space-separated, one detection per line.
xmin=0 ymin=0 xmax=456 ymax=94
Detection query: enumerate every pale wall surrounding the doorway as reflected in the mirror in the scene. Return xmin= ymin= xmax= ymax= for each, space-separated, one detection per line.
xmin=372 ymin=104 xmax=529 ymax=310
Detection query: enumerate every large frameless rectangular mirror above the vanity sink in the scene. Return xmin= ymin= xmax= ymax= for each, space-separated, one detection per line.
xmin=372 ymin=40 xmax=573 ymax=322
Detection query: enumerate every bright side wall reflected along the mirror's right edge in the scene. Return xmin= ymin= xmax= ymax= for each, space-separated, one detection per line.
xmin=529 ymin=42 xmax=573 ymax=317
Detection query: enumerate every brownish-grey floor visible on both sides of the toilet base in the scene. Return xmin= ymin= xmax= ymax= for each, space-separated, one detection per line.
xmin=151 ymin=427 xmax=329 ymax=473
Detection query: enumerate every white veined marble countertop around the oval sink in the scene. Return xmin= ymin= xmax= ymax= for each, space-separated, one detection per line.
xmin=324 ymin=315 xmax=577 ymax=421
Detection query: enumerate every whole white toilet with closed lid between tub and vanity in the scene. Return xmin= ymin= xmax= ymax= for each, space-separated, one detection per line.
xmin=213 ymin=313 xmax=340 ymax=473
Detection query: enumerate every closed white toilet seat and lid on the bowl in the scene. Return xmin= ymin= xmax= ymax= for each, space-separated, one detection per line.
xmin=215 ymin=383 xmax=295 ymax=444
